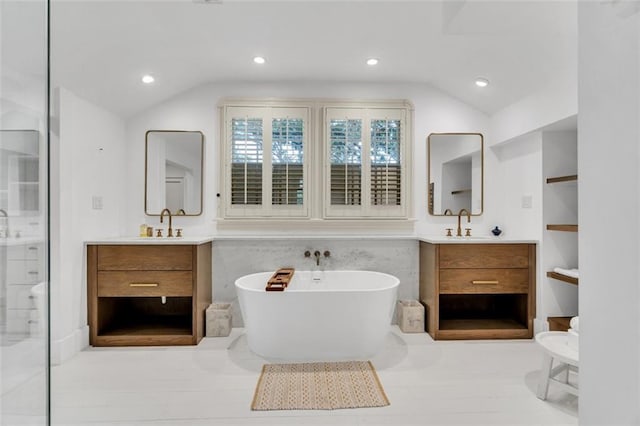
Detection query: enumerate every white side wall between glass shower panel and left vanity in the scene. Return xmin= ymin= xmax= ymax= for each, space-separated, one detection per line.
xmin=50 ymin=88 xmax=128 ymax=364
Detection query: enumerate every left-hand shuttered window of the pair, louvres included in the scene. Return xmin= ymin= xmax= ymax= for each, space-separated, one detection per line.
xmin=221 ymin=106 xmax=309 ymax=218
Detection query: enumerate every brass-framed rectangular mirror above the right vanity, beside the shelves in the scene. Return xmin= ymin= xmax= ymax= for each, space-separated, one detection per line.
xmin=427 ymin=133 xmax=484 ymax=216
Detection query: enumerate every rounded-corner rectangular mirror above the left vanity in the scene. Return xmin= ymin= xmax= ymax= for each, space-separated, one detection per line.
xmin=144 ymin=130 xmax=204 ymax=216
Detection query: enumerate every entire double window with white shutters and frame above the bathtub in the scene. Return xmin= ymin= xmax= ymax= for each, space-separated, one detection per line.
xmin=218 ymin=99 xmax=412 ymax=221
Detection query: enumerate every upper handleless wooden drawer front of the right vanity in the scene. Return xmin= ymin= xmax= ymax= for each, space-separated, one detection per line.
xmin=439 ymin=244 xmax=529 ymax=268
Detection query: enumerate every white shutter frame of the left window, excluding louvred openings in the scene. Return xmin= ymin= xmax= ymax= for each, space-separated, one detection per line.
xmin=220 ymin=104 xmax=312 ymax=218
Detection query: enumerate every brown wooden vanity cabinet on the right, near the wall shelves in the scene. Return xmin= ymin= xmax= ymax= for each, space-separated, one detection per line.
xmin=420 ymin=242 xmax=536 ymax=340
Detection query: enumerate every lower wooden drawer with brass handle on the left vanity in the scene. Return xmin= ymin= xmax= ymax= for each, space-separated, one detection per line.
xmin=98 ymin=271 xmax=193 ymax=297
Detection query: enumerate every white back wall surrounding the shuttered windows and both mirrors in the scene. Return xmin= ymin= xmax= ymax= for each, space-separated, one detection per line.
xmin=126 ymin=82 xmax=492 ymax=235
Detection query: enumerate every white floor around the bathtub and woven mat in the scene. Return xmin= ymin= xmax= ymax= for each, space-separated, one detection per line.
xmin=51 ymin=326 xmax=578 ymax=426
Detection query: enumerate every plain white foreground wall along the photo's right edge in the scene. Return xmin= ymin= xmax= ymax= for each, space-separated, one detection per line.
xmin=578 ymin=2 xmax=640 ymax=425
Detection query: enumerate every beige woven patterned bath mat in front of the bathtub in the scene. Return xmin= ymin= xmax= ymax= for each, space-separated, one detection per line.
xmin=251 ymin=361 xmax=389 ymax=410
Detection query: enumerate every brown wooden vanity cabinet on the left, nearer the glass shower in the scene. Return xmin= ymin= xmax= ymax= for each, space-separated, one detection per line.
xmin=87 ymin=242 xmax=212 ymax=346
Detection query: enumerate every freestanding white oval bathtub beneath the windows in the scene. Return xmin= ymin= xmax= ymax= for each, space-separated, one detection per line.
xmin=235 ymin=271 xmax=400 ymax=360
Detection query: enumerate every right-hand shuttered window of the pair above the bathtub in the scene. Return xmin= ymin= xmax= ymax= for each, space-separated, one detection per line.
xmin=324 ymin=107 xmax=407 ymax=218
